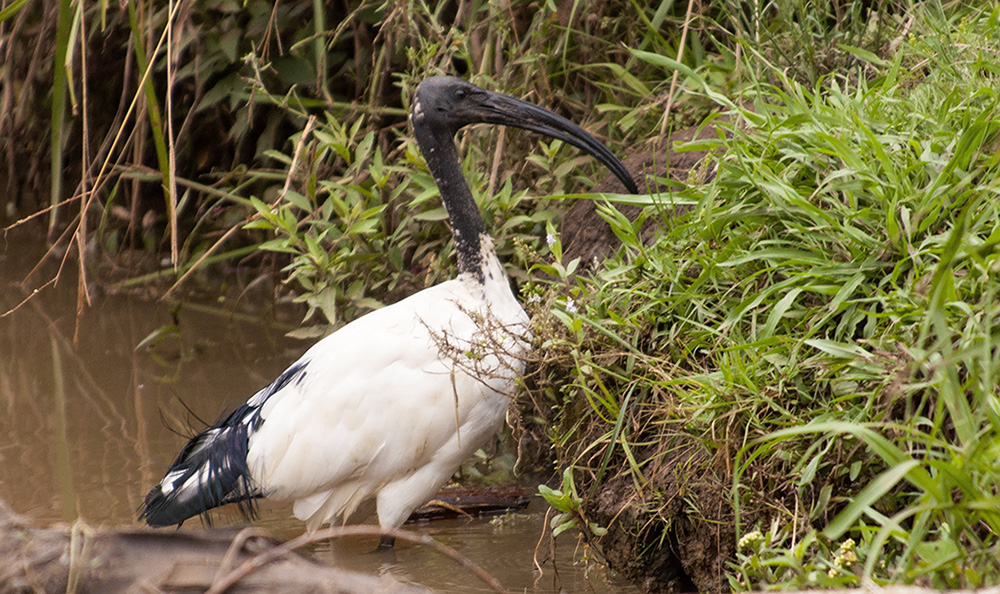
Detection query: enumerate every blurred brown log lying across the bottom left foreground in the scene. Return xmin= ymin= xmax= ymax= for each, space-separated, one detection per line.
xmin=0 ymin=494 xmax=427 ymax=594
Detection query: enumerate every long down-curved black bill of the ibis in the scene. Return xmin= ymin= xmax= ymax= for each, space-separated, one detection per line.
xmin=470 ymin=91 xmax=639 ymax=194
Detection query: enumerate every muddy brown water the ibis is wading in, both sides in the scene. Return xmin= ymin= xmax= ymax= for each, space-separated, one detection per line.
xmin=0 ymin=242 xmax=638 ymax=593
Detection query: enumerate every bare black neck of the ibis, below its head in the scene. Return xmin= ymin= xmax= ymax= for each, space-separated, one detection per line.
xmin=413 ymin=125 xmax=486 ymax=282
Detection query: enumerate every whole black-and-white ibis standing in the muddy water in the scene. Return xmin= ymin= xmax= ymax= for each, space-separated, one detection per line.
xmin=141 ymin=77 xmax=635 ymax=540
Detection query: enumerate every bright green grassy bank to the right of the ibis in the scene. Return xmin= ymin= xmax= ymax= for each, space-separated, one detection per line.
xmin=520 ymin=7 xmax=1000 ymax=590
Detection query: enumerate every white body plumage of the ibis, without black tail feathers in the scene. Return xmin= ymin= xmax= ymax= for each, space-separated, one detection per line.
xmin=247 ymin=243 xmax=528 ymax=528
